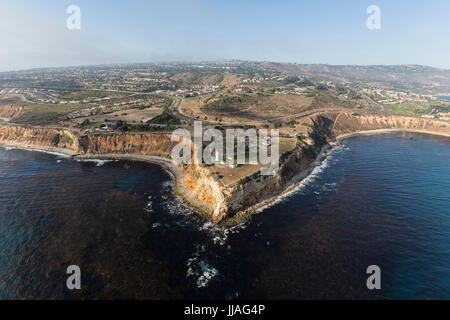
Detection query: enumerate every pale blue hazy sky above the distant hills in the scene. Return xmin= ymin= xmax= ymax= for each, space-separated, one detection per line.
xmin=0 ymin=0 xmax=450 ymax=71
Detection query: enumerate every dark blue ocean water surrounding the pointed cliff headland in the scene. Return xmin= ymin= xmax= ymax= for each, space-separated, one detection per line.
xmin=0 ymin=134 xmax=450 ymax=299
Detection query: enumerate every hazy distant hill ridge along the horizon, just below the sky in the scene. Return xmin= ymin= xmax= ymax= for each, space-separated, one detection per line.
xmin=0 ymin=60 xmax=450 ymax=96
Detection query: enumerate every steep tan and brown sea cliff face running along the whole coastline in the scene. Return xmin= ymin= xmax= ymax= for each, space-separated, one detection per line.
xmin=0 ymin=113 xmax=450 ymax=223
